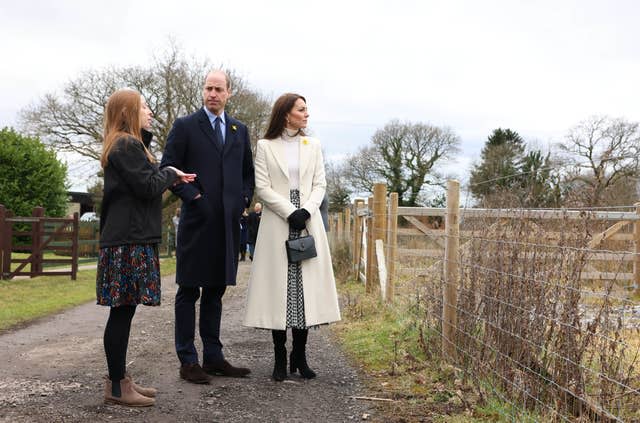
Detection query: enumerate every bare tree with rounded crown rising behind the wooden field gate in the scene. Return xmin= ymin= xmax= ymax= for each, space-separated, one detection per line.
xmin=346 ymin=120 xmax=460 ymax=206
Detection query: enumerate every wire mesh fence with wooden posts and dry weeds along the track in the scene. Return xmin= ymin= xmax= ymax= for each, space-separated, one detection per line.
xmin=331 ymin=181 xmax=640 ymax=422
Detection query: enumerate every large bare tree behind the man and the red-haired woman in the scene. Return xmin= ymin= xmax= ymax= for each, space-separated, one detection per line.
xmin=21 ymin=43 xmax=271 ymax=164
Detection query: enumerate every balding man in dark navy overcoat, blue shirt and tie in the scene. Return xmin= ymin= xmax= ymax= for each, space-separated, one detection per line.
xmin=160 ymin=71 xmax=255 ymax=383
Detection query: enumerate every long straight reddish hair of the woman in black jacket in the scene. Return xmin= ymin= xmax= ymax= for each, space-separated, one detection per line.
xmin=100 ymin=89 xmax=156 ymax=169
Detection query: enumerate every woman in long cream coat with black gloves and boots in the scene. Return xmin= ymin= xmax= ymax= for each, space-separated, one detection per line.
xmin=244 ymin=93 xmax=340 ymax=381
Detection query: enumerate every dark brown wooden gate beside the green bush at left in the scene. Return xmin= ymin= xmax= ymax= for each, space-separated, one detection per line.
xmin=0 ymin=204 xmax=78 ymax=280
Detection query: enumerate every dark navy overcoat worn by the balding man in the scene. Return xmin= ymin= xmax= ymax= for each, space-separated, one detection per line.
xmin=160 ymin=109 xmax=255 ymax=287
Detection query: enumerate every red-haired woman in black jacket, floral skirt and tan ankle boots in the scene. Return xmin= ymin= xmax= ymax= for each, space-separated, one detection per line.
xmin=96 ymin=90 xmax=196 ymax=407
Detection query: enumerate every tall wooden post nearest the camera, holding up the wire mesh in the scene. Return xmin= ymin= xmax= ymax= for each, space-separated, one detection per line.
xmin=442 ymin=179 xmax=460 ymax=359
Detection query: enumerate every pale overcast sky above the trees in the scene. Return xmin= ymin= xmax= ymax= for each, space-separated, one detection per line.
xmin=0 ymin=0 xmax=640 ymax=189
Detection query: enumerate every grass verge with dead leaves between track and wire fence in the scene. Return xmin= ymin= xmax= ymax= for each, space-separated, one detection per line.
xmin=332 ymin=281 xmax=536 ymax=423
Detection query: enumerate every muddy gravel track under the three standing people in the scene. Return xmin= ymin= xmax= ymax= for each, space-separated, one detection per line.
xmin=0 ymin=263 xmax=377 ymax=423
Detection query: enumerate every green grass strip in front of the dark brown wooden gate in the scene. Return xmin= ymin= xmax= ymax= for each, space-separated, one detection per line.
xmin=0 ymin=259 xmax=176 ymax=332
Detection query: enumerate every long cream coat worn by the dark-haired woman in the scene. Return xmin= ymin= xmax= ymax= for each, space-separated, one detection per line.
xmin=243 ymin=136 xmax=340 ymax=329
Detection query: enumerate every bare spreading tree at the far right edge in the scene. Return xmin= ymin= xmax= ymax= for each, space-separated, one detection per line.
xmin=558 ymin=116 xmax=640 ymax=206
